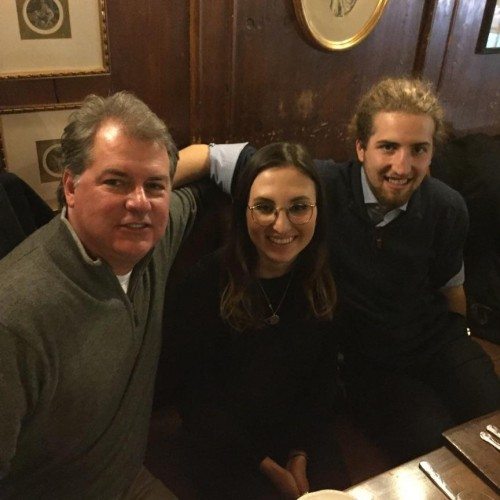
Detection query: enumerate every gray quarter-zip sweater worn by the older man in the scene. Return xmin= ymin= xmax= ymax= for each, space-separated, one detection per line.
xmin=0 ymin=189 xmax=196 ymax=500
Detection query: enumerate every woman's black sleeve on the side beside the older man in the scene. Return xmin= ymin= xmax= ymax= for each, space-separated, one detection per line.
xmin=164 ymin=260 xmax=272 ymax=466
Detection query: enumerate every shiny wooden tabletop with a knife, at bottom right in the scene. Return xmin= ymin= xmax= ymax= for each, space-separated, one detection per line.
xmin=346 ymin=447 xmax=500 ymax=500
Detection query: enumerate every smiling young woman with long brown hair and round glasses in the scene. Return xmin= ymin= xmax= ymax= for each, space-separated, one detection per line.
xmin=172 ymin=143 xmax=347 ymax=500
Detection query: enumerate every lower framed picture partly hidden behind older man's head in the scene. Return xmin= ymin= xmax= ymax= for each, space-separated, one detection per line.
xmin=0 ymin=103 xmax=79 ymax=210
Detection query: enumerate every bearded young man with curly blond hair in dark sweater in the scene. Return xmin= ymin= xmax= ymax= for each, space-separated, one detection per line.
xmin=201 ymin=78 xmax=500 ymax=461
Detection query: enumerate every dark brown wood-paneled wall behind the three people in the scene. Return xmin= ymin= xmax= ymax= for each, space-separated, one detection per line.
xmin=0 ymin=0 xmax=500 ymax=164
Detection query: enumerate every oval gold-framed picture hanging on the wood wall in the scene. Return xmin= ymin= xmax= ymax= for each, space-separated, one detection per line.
xmin=293 ymin=0 xmax=387 ymax=50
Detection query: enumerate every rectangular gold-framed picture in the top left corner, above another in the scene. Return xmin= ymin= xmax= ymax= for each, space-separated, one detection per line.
xmin=0 ymin=0 xmax=109 ymax=79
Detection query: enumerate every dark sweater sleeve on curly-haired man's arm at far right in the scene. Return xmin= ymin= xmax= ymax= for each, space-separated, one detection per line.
xmin=430 ymin=191 xmax=469 ymax=289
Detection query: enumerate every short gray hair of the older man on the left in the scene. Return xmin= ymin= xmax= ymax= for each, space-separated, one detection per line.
xmin=58 ymin=91 xmax=179 ymax=206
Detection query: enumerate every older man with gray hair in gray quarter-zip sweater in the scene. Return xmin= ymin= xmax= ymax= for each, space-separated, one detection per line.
xmin=0 ymin=92 xmax=209 ymax=499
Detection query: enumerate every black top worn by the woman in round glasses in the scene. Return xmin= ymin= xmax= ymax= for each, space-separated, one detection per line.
xmin=172 ymin=252 xmax=336 ymax=463
